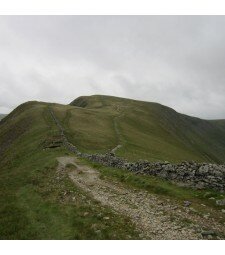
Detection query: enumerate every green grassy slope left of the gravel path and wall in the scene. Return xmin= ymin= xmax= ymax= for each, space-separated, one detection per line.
xmin=0 ymin=102 xmax=137 ymax=239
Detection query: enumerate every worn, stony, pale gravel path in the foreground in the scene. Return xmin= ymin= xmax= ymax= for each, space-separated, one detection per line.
xmin=58 ymin=157 xmax=224 ymax=239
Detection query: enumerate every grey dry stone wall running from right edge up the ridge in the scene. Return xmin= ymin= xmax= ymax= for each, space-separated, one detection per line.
xmin=50 ymin=110 xmax=225 ymax=192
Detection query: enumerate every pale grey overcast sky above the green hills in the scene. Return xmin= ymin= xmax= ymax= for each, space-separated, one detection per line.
xmin=0 ymin=16 xmax=225 ymax=119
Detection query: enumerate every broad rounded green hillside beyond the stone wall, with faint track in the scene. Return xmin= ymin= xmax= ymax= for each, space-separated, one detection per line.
xmin=69 ymin=96 xmax=225 ymax=162
